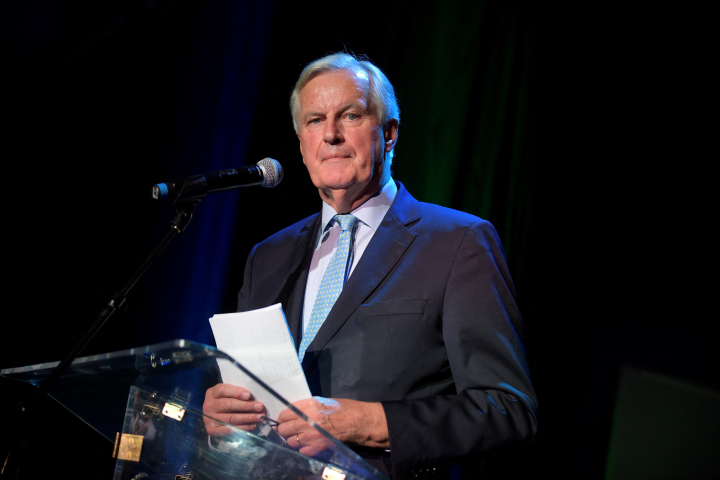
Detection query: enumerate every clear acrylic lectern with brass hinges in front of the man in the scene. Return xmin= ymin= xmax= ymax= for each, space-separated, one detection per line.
xmin=0 ymin=340 xmax=386 ymax=480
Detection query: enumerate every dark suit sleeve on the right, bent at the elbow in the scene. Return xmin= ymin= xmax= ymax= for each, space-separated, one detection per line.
xmin=383 ymin=220 xmax=537 ymax=478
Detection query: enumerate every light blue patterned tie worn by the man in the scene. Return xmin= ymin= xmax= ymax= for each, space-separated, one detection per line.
xmin=298 ymin=215 xmax=357 ymax=362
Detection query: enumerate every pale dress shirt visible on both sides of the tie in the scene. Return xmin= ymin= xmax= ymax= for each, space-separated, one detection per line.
xmin=303 ymin=178 xmax=397 ymax=334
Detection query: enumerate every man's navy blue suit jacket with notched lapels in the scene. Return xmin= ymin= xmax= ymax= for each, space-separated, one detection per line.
xmin=238 ymin=182 xmax=537 ymax=478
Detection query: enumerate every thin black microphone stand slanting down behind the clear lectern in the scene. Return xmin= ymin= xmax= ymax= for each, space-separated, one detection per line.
xmin=0 ymin=201 xmax=200 ymax=478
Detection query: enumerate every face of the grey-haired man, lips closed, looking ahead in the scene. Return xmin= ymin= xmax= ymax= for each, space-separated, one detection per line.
xmin=298 ymin=71 xmax=397 ymax=208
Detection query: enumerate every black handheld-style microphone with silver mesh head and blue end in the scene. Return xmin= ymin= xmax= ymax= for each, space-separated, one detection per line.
xmin=153 ymin=158 xmax=284 ymax=203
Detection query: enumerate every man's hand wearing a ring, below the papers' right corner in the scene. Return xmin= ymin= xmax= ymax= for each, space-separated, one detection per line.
xmin=277 ymin=397 xmax=390 ymax=456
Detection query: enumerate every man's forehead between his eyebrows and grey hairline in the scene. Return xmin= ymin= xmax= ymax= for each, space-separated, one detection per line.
xmin=300 ymin=70 xmax=370 ymax=110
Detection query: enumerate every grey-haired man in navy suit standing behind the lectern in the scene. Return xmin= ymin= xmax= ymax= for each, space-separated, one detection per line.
xmin=204 ymin=53 xmax=537 ymax=478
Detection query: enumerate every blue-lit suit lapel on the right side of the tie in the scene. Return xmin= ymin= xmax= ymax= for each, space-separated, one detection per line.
xmin=302 ymin=182 xmax=420 ymax=370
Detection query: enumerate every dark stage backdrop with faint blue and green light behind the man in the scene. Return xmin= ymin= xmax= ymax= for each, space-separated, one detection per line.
xmin=0 ymin=0 xmax=720 ymax=478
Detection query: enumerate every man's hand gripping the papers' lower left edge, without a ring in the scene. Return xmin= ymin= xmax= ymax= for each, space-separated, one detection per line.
xmin=203 ymin=383 xmax=265 ymax=437
